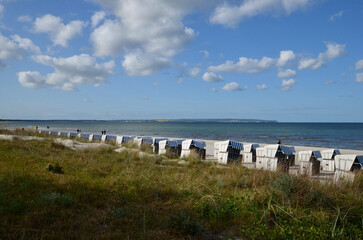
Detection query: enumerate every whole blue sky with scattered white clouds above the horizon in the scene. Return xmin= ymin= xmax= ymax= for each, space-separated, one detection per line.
xmin=0 ymin=0 xmax=363 ymax=122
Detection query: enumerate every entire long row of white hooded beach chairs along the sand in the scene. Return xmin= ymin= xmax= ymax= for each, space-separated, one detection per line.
xmin=39 ymin=131 xmax=363 ymax=181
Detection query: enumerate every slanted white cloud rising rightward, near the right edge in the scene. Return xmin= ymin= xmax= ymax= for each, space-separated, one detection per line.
xmin=298 ymin=43 xmax=347 ymax=70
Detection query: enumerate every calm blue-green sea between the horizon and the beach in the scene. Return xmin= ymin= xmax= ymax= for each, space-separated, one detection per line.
xmin=0 ymin=120 xmax=363 ymax=150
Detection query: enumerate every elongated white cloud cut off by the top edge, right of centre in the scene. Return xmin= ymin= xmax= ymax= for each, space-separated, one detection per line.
xmin=210 ymin=0 xmax=313 ymax=27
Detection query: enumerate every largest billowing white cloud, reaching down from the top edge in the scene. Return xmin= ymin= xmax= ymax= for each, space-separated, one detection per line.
xmin=91 ymin=0 xmax=202 ymax=76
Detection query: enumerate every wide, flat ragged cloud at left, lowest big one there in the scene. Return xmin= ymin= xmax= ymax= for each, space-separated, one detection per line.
xmin=18 ymin=54 xmax=115 ymax=91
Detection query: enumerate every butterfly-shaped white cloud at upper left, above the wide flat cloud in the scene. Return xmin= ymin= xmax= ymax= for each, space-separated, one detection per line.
xmin=34 ymin=14 xmax=87 ymax=47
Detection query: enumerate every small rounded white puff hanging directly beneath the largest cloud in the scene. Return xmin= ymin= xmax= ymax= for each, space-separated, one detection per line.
xmin=122 ymin=52 xmax=172 ymax=76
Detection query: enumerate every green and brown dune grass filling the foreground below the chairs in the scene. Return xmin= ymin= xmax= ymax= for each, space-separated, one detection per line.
xmin=0 ymin=132 xmax=363 ymax=239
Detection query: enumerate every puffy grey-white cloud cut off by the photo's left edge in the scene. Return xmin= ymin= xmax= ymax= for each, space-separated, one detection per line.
xmin=0 ymin=33 xmax=40 ymax=67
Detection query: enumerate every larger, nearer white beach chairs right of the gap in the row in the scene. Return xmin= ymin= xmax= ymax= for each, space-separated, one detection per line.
xmin=214 ymin=140 xmax=363 ymax=181
